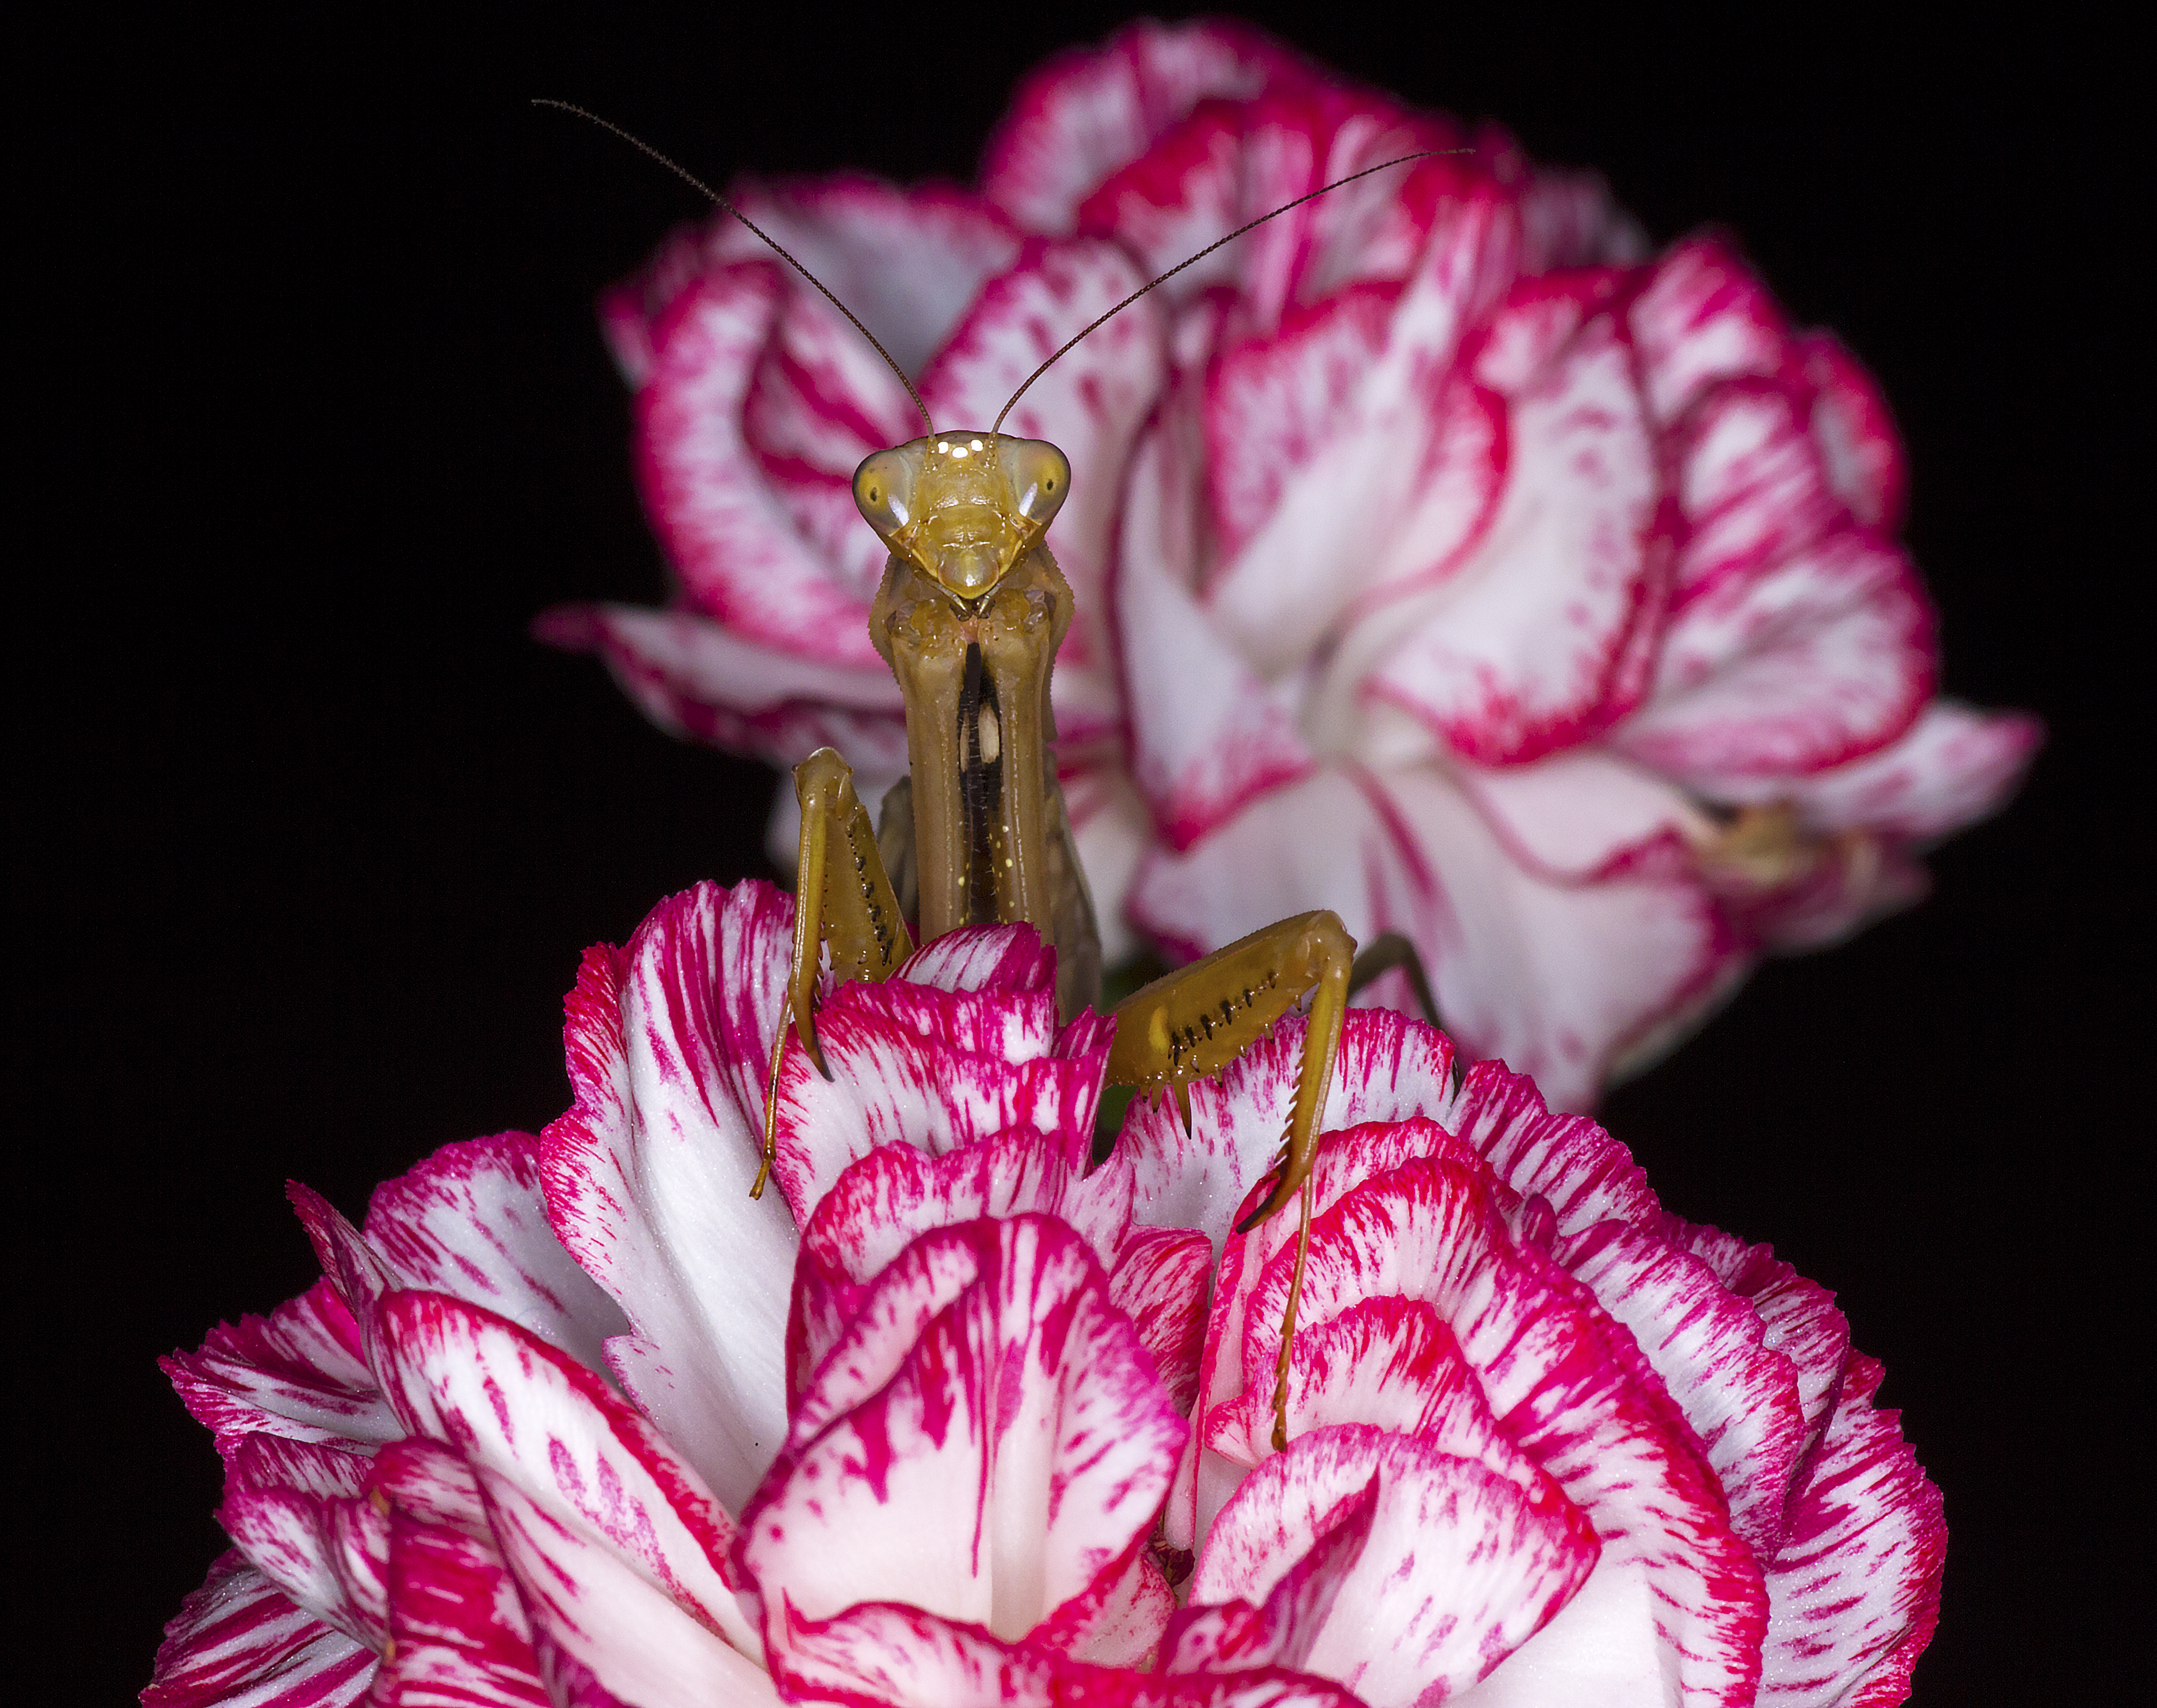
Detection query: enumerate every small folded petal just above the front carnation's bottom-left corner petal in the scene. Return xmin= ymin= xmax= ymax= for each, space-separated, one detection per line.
xmin=218 ymin=1441 xmax=388 ymax=1650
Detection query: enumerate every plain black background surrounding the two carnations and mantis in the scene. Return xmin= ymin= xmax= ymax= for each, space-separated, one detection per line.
xmin=21 ymin=4 xmax=2151 ymax=1704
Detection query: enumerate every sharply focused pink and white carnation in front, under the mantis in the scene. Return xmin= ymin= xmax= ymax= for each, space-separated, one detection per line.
xmin=142 ymin=884 xmax=1943 ymax=1708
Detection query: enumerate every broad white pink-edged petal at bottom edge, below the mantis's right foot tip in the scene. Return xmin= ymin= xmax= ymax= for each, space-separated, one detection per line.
xmin=1191 ymin=1423 xmax=1598 ymax=1708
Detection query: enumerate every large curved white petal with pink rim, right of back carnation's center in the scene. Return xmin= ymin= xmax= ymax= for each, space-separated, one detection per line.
xmin=1370 ymin=304 xmax=1667 ymax=766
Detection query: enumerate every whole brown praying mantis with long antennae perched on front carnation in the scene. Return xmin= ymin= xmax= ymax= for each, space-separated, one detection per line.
xmin=537 ymin=101 xmax=1471 ymax=1449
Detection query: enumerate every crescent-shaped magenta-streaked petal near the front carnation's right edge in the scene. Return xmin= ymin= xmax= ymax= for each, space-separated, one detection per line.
xmin=1557 ymin=1221 xmax=1806 ymax=1559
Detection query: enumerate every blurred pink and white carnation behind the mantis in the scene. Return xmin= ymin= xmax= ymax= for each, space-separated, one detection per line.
xmin=541 ymin=24 xmax=2038 ymax=1107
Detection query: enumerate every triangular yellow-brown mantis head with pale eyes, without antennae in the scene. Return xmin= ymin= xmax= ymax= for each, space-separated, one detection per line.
xmin=854 ymin=431 xmax=1072 ymax=601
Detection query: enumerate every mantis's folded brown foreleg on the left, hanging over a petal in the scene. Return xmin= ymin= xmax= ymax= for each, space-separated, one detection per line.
xmin=748 ymin=748 xmax=914 ymax=1197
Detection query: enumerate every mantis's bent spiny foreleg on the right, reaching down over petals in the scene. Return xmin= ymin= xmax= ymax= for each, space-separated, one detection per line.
xmin=1109 ymin=912 xmax=1355 ymax=1452
